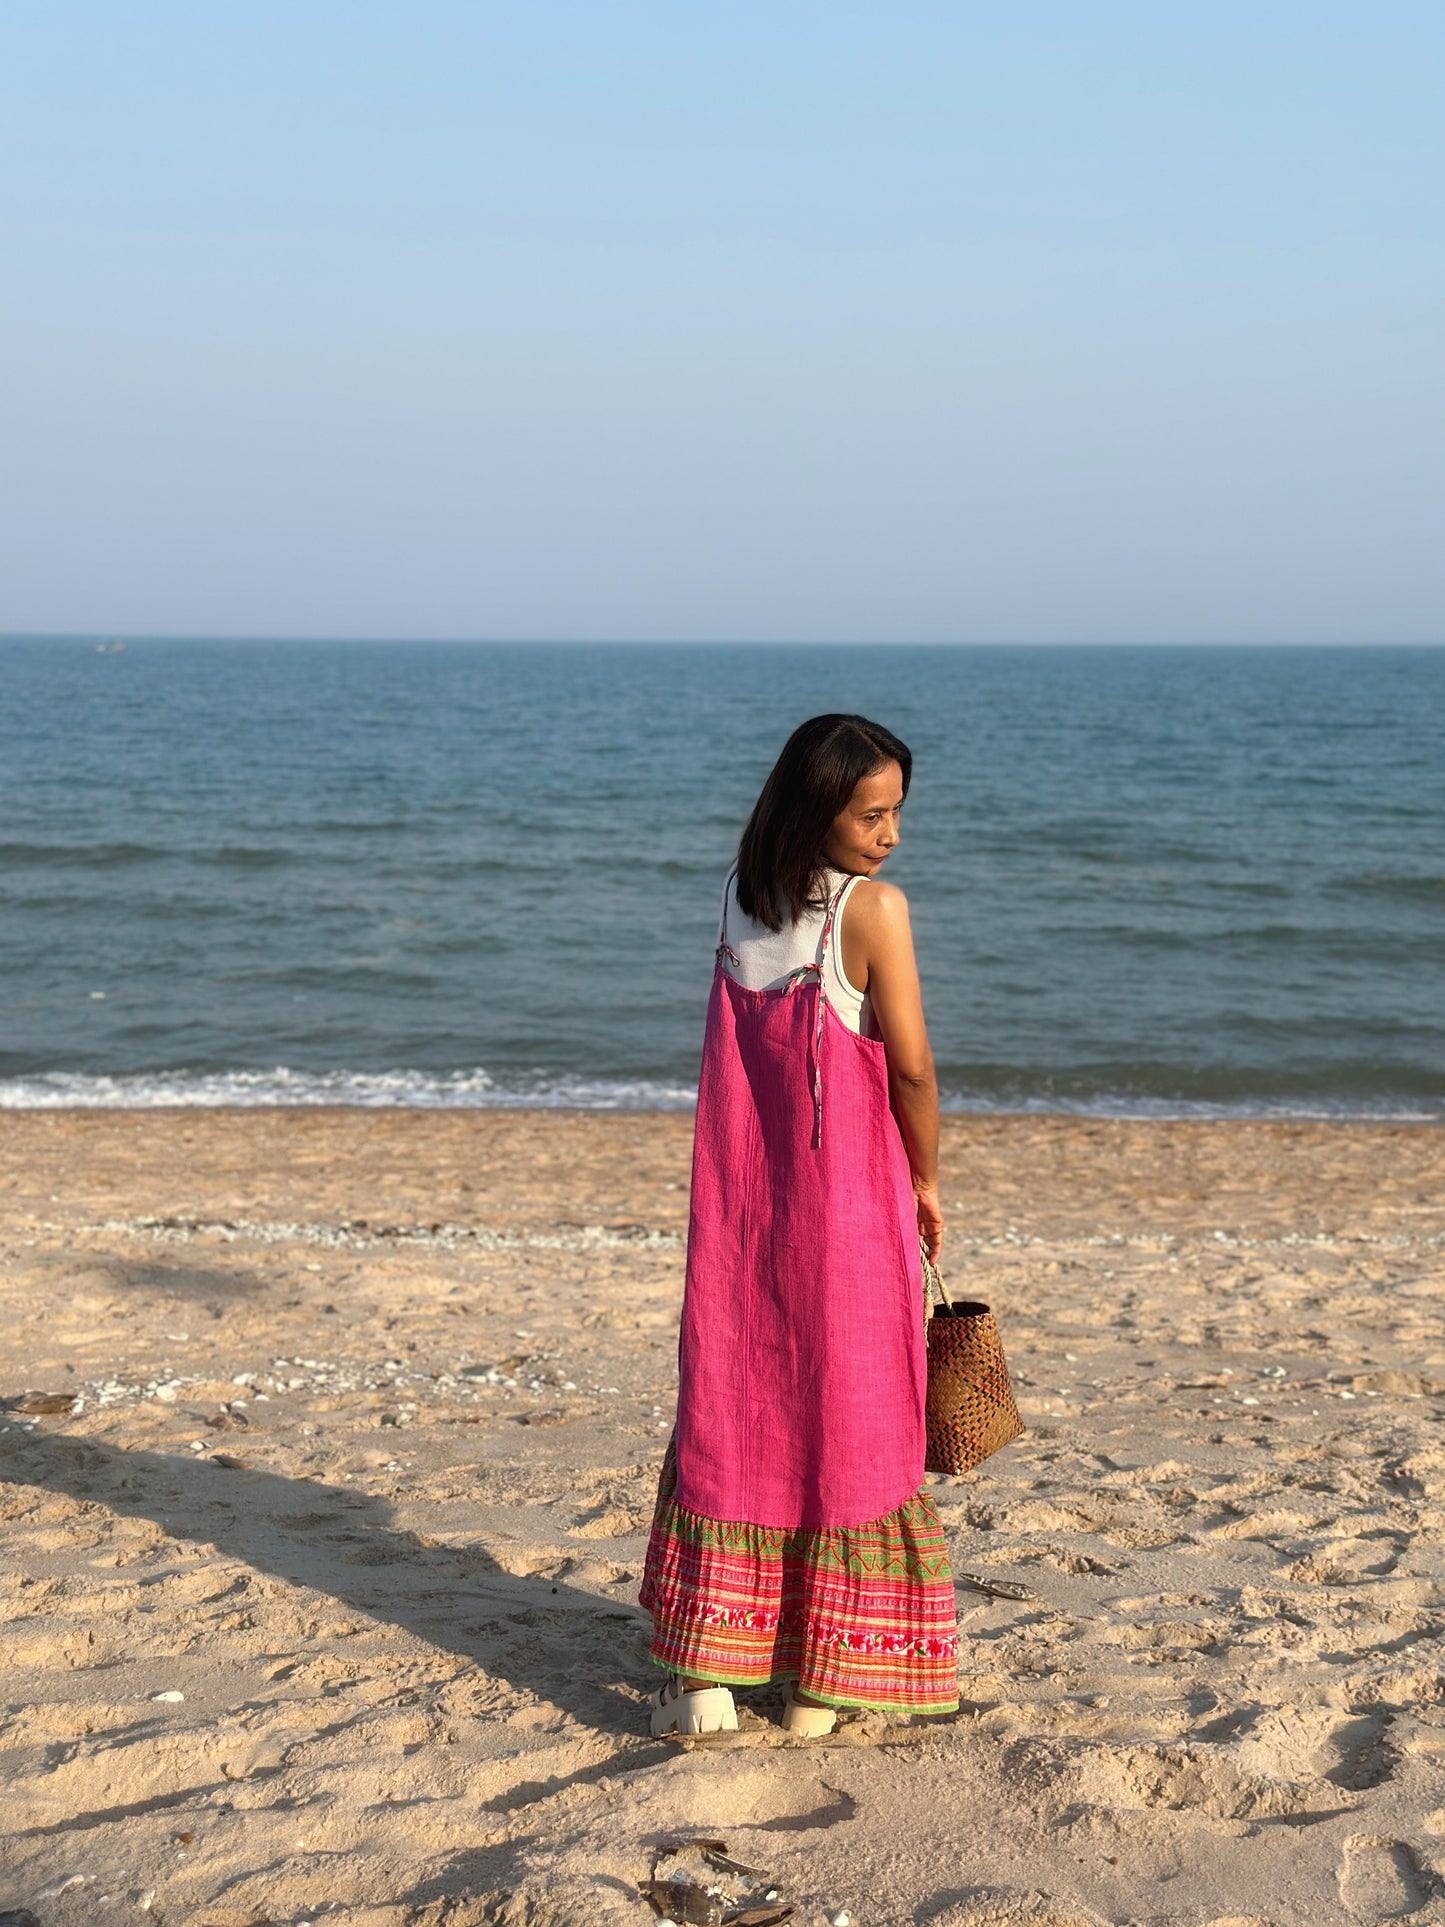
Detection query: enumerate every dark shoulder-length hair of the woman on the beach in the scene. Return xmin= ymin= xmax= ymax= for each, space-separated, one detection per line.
xmin=738 ymin=715 xmax=913 ymax=931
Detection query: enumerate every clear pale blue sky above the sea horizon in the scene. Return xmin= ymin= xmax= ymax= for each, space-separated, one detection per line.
xmin=0 ymin=0 xmax=1445 ymax=642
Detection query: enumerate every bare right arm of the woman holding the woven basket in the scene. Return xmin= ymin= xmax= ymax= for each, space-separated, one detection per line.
xmin=842 ymin=881 xmax=944 ymax=1260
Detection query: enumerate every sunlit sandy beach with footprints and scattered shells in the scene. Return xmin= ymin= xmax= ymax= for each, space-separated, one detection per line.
xmin=0 ymin=1110 xmax=1445 ymax=1927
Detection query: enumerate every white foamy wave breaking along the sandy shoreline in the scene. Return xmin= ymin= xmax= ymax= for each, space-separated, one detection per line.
xmin=0 ymin=1066 xmax=1445 ymax=1123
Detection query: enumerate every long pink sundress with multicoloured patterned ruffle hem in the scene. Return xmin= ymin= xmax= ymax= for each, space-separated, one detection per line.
xmin=640 ymin=871 xmax=958 ymax=1713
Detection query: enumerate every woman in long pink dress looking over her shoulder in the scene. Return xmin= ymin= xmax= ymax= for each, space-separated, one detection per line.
xmin=642 ymin=715 xmax=958 ymax=1736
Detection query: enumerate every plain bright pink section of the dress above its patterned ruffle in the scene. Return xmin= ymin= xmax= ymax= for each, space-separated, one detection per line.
xmin=676 ymin=871 xmax=927 ymax=1526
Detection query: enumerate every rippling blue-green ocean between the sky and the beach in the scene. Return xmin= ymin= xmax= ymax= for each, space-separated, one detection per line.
xmin=0 ymin=638 xmax=1445 ymax=1120
